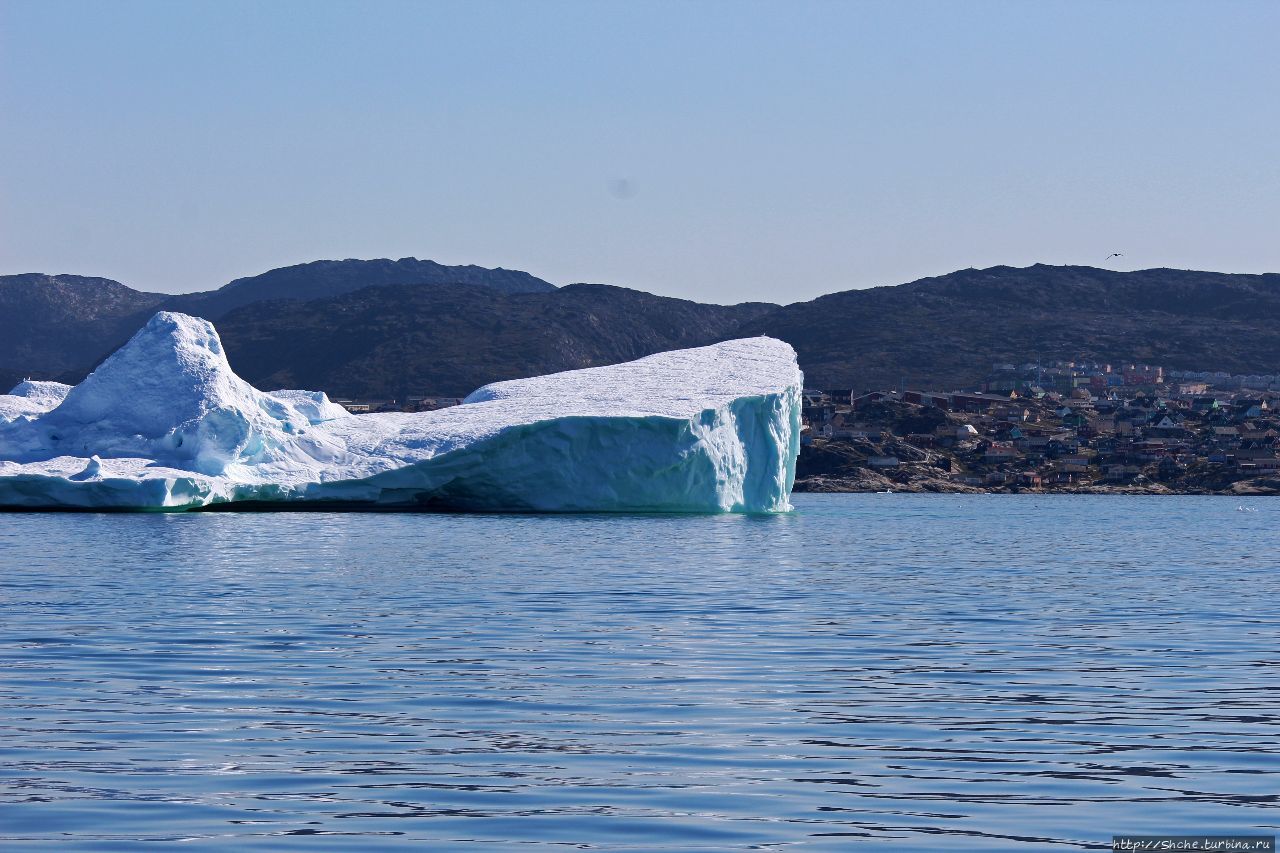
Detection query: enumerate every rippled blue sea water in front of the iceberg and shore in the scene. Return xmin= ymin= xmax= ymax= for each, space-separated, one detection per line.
xmin=0 ymin=494 xmax=1280 ymax=850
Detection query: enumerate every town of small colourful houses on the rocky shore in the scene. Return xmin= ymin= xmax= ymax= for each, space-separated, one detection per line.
xmin=801 ymin=362 xmax=1280 ymax=491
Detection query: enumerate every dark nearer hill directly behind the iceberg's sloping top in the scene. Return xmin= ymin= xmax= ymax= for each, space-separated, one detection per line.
xmin=218 ymin=284 xmax=776 ymax=397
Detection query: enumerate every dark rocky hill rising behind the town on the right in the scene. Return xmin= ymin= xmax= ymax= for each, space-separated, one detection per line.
xmin=740 ymin=264 xmax=1280 ymax=389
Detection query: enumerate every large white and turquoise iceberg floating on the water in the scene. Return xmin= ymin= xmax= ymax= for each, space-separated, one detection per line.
xmin=0 ymin=313 xmax=801 ymax=512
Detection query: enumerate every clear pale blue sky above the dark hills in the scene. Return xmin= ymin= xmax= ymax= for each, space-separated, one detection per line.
xmin=0 ymin=0 xmax=1280 ymax=302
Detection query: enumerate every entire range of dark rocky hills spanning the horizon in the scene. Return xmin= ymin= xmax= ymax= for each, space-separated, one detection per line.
xmin=0 ymin=259 xmax=1280 ymax=397
